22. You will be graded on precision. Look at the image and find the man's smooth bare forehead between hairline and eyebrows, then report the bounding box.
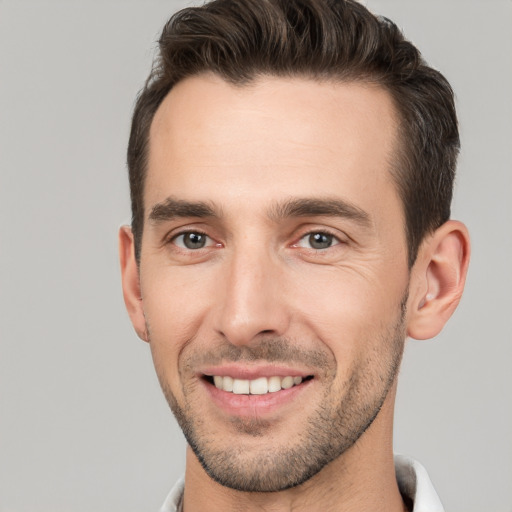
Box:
[145,75,397,224]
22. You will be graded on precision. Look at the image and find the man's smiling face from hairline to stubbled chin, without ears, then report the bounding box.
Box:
[135,75,409,491]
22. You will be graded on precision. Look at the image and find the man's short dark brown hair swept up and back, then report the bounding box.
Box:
[128,0,459,266]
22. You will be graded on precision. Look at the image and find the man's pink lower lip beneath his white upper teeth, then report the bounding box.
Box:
[203,379,313,418]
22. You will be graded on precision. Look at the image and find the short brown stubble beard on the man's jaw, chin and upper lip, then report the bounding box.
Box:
[148,293,407,492]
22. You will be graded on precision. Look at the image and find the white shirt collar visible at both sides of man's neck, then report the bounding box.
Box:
[160,455,444,512]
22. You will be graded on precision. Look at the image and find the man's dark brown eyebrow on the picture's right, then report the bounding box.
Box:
[269,198,371,227]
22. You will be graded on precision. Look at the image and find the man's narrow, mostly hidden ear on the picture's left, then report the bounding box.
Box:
[119,226,149,341]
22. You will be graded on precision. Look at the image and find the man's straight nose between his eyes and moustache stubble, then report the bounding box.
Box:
[216,248,290,346]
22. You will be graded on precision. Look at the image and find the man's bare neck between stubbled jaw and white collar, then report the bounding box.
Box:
[184,393,406,512]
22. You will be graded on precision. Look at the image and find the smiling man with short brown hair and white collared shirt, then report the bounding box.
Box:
[120,0,469,512]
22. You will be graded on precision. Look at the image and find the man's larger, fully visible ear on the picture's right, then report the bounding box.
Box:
[407,220,470,340]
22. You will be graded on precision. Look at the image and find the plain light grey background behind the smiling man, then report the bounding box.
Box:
[0,0,512,512]
